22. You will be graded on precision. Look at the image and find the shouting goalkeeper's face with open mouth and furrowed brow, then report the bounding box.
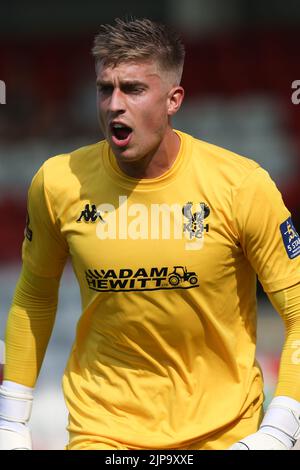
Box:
[96,61,180,162]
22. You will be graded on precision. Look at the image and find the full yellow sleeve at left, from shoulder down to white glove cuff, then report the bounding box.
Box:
[4,166,68,387]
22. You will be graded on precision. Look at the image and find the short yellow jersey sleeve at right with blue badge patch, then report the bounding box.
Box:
[233,167,300,292]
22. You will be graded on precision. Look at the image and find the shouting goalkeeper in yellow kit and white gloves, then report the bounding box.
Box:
[0,19,300,450]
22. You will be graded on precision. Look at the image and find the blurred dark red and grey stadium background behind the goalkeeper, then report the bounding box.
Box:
[0,0,300,449]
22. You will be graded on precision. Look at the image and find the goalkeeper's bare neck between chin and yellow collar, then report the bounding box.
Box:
[117,128,180,179]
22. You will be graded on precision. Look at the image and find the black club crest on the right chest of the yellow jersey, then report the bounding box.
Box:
[182,202,210,240]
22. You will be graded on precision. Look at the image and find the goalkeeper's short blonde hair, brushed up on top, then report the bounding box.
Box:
[92,18,185,84]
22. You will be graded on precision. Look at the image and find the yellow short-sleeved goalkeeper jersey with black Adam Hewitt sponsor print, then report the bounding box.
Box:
[23,131,300,448]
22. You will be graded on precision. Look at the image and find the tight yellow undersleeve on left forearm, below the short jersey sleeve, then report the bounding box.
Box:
[4,266,60,387]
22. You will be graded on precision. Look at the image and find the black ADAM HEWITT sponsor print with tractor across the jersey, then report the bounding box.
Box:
[85,265,199,292]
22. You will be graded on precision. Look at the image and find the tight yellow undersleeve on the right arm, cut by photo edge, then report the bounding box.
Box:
[268,283,300,401]
